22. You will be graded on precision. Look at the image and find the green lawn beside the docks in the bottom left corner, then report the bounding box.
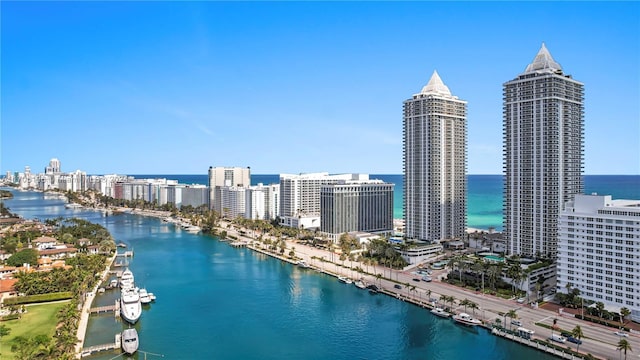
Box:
[0,301,68,360]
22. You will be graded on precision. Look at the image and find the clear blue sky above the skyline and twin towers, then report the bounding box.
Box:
[0,1,640,174]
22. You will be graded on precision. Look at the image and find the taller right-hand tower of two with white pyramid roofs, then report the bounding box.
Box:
[503,44,584,258]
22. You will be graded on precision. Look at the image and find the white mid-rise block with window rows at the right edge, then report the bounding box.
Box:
[556,195,640,322]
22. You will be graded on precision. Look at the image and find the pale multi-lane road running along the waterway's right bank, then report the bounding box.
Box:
[221,222,640,359]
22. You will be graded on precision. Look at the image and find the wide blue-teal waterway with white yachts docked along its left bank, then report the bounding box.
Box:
[5,192,553,360]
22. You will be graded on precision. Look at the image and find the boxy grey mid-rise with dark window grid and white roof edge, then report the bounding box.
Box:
[320,180,394,241]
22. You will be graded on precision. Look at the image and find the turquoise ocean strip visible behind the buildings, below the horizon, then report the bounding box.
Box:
[133,174,640,231]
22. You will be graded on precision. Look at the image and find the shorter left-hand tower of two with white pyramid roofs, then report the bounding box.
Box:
[403,71,467,242]
